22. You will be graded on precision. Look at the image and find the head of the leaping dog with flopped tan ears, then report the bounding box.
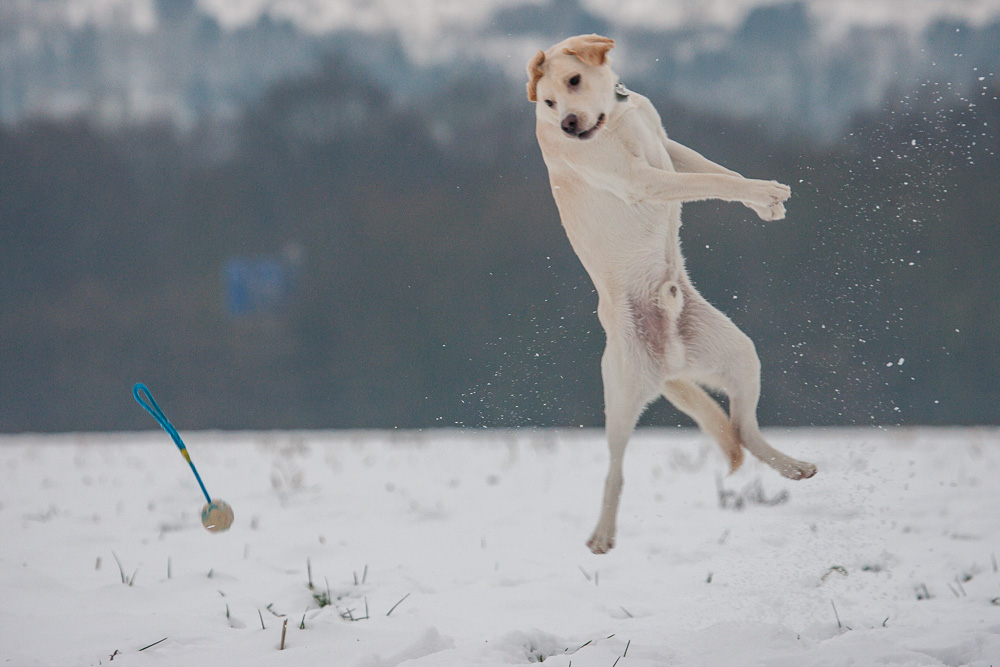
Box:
[528,35,618,140]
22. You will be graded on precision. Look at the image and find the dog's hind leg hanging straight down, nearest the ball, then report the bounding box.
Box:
[587,336,655,554]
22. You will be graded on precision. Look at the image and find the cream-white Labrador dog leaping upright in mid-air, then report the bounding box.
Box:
[528,35,816,553]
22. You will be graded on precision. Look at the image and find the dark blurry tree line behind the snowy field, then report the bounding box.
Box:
[0,58,1000,432]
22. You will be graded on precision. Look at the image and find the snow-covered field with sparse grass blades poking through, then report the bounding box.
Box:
[0,429,1000,667]
